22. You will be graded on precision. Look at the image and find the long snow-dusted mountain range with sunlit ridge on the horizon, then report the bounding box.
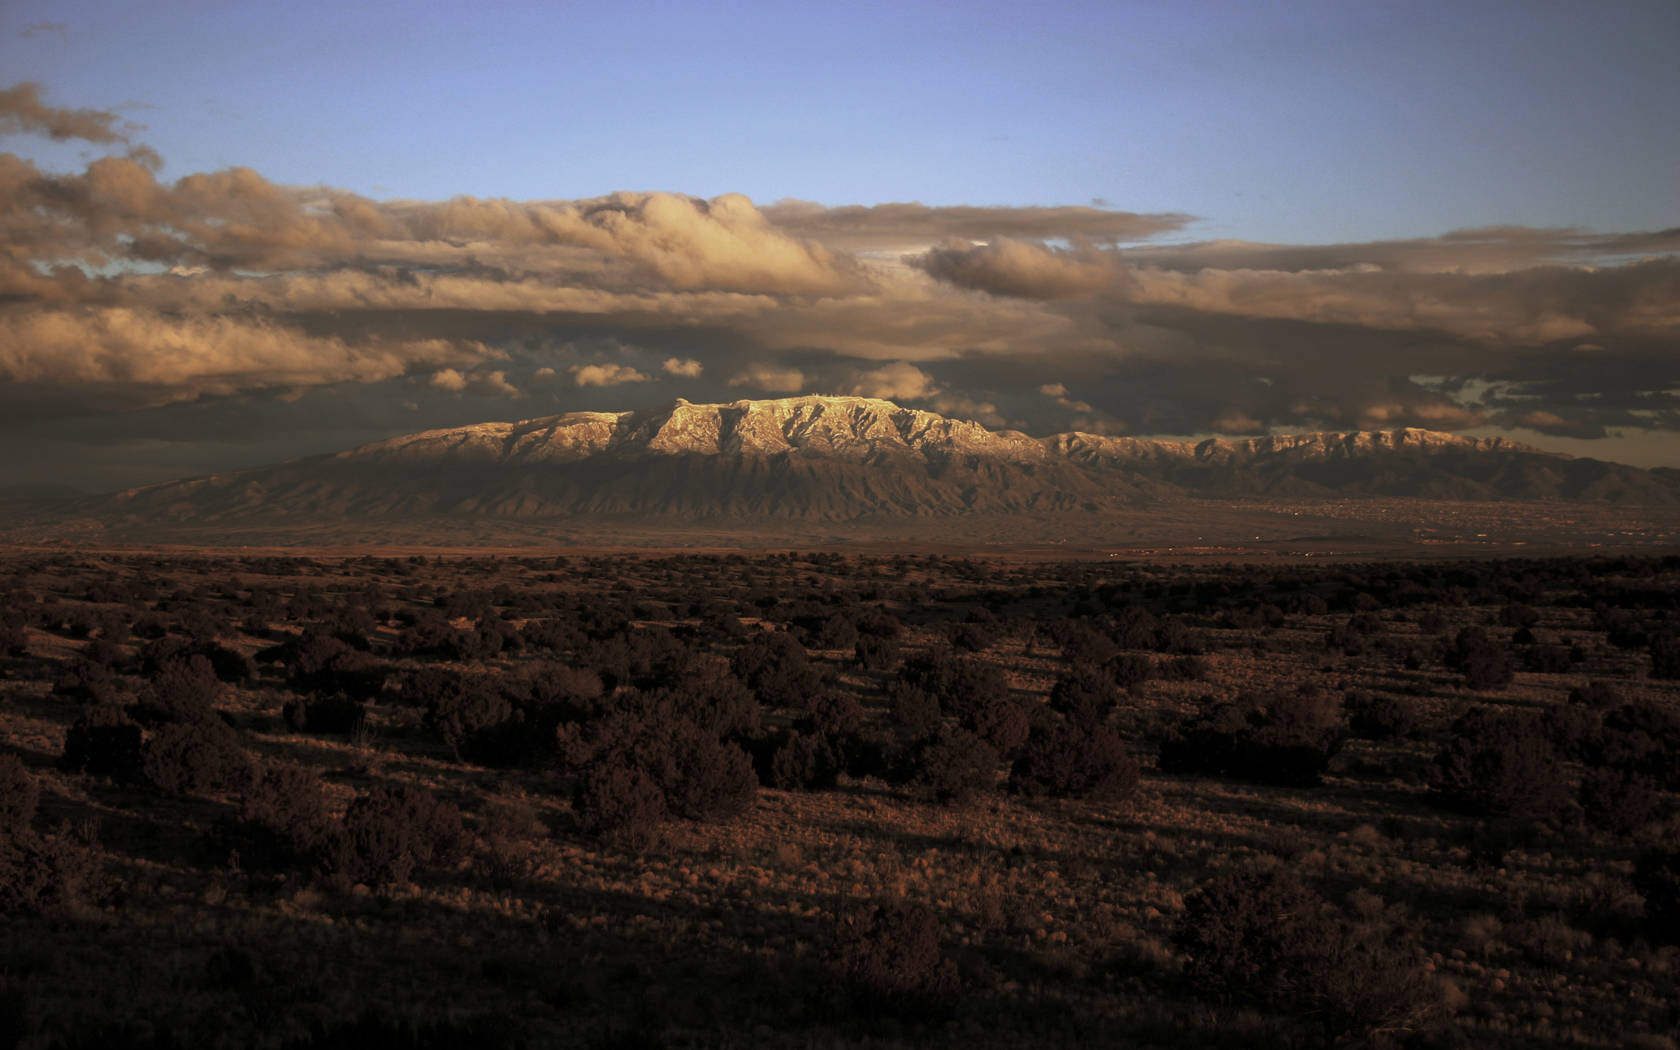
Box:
[10,396,1680,547]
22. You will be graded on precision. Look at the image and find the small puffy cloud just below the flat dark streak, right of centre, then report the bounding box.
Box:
[906,237,1117,299]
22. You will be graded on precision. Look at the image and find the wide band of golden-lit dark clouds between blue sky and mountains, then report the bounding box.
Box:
[0,84,1680,483]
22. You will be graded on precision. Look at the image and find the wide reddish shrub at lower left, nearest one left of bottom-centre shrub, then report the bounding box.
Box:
[324,786,470,885]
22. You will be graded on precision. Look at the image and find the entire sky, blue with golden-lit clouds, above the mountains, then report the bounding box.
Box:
[0,0,1680,492]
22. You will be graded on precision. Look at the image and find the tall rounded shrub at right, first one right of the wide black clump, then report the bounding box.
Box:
[1430,707,1566,820]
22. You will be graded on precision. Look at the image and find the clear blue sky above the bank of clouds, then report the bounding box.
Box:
[0,0,1680,244]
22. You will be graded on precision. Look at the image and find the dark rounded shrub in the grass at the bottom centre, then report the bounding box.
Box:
[828,902,961,1018]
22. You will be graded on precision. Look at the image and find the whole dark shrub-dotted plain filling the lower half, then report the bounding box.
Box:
[0,549,1680,1048]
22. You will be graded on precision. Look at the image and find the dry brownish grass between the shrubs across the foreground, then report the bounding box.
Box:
[0,544,1680,1048]
